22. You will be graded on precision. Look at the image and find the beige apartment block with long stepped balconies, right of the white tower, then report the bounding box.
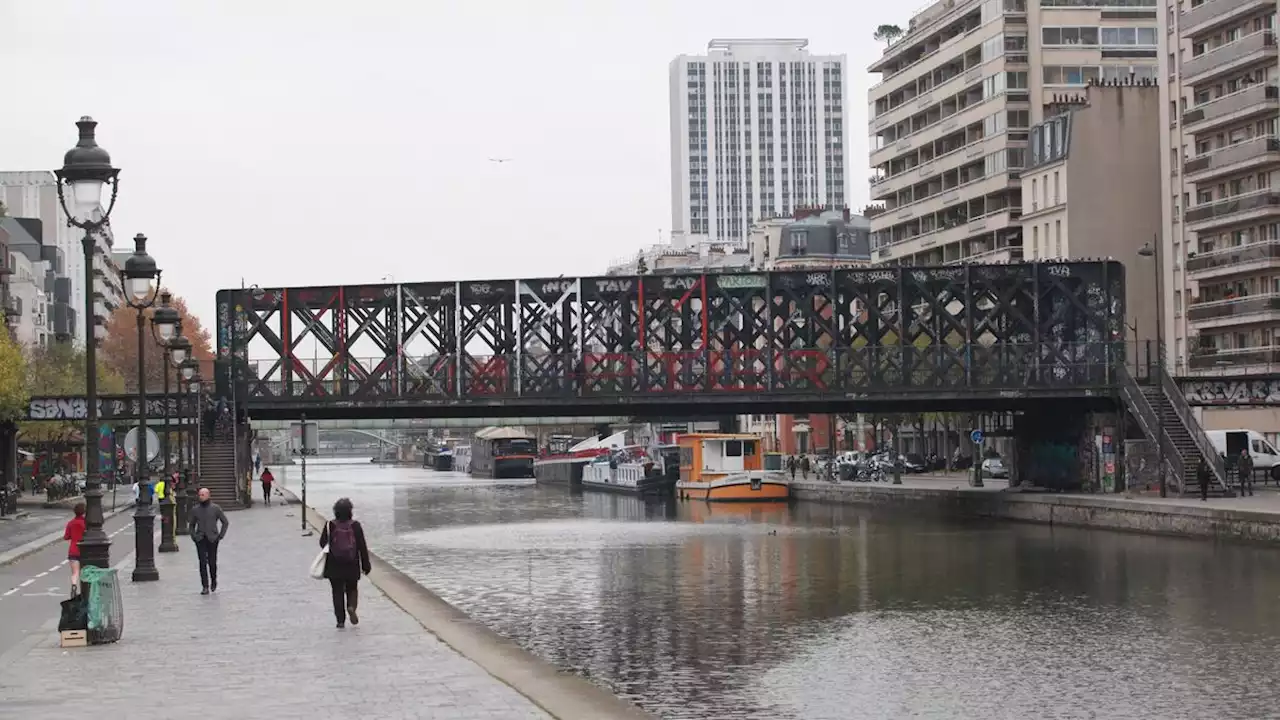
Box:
[869,0,1160,265]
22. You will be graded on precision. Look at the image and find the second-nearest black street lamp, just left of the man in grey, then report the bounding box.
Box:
[124,233,162,582]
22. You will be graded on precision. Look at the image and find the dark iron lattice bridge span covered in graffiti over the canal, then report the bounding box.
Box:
[216,261,1125,420]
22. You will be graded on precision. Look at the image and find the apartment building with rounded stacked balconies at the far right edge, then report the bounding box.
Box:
[1164,0,1280,433]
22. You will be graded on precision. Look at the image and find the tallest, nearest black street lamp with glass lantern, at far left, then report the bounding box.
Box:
[54,115,120,569]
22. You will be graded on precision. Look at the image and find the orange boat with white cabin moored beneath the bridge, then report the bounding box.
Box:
[676,433,791,502]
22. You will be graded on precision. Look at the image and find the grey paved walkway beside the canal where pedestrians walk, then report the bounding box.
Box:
[0,505,549,720]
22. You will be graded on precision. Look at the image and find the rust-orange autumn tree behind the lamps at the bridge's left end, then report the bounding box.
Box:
[100,289,214,392]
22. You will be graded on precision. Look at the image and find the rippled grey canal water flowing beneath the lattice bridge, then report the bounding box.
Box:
[287,464,1280,720]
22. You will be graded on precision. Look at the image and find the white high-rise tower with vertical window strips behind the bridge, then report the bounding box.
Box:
[669,38,846,247]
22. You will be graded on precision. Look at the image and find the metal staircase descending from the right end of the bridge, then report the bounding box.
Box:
[1117,366,1235,497]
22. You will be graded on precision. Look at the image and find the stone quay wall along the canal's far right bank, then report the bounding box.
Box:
[792,474,1280,546]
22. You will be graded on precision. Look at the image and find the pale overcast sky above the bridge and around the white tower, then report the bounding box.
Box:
[0,0,896,325]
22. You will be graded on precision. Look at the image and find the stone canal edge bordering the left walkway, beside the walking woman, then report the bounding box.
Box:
[279,487,653,720]
